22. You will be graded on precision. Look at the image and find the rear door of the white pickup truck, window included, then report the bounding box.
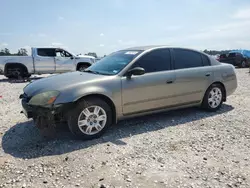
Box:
[33,48,55,73]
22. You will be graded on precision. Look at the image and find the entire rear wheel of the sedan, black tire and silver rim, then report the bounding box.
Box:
[202,84,225,112]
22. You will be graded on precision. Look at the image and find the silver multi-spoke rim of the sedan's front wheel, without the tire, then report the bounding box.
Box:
[78,106,107,135]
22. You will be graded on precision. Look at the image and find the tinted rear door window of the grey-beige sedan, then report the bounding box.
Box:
[174,49,203,69]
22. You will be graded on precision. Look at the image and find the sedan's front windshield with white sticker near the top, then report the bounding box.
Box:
[86,50,142,75]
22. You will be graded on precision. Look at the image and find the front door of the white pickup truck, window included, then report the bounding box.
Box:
[55,49,75,72]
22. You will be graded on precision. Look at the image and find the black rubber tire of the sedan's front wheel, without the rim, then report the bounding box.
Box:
[67,97,112,140]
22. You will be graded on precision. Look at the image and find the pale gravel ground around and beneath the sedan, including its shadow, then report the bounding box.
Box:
[0,69,250,188]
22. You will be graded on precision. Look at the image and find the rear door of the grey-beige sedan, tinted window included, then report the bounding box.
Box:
[173,48,213,105]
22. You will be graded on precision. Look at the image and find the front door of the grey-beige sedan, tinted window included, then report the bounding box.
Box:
[122,49,175,115]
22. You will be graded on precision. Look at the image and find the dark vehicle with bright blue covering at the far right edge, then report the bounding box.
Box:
[219,50,250,68]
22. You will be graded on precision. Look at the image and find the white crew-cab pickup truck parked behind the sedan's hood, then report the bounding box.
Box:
[0,47,95,78]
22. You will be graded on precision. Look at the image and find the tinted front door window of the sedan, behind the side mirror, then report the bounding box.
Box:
[132,49,171,73]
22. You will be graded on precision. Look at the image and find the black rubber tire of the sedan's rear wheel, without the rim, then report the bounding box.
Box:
[201,84,225,112]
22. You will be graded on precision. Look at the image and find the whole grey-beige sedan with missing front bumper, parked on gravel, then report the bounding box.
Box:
[20,46,237,139]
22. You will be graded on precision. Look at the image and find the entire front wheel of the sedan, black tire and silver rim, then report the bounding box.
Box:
[68,98,112,140]
